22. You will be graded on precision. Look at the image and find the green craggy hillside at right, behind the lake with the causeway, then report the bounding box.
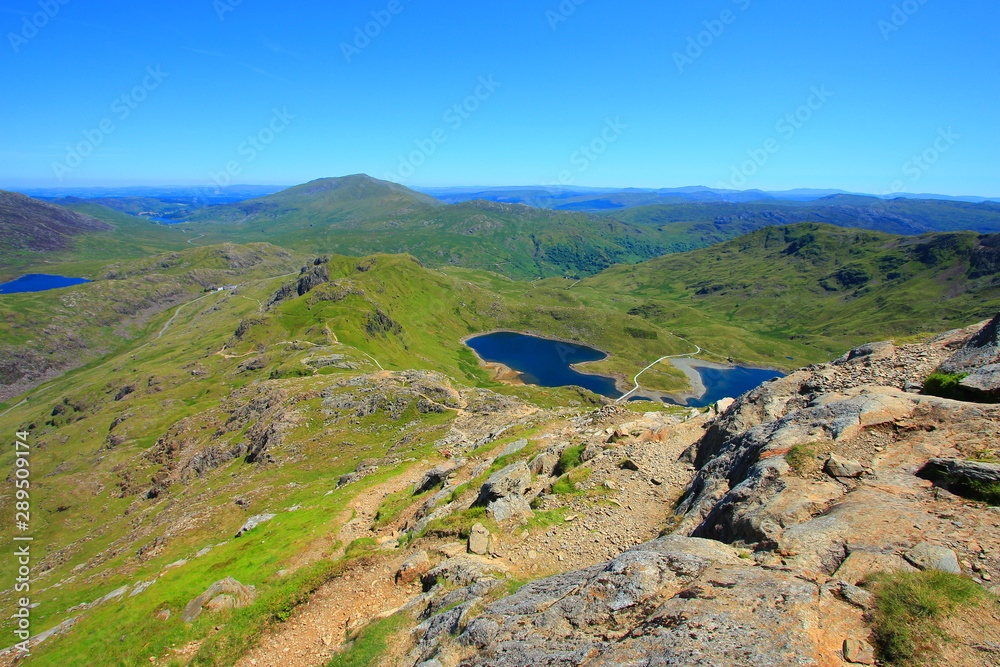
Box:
[574,223,1000,346]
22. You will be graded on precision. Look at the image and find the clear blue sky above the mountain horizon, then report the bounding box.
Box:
[0,0,1000,196]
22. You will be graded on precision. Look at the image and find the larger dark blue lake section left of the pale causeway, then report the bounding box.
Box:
[465,331,621,398]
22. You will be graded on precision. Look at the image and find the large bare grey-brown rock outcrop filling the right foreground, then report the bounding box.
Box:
[401,318,1000,667]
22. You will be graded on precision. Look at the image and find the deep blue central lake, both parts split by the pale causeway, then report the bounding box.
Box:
[466,331,783,408]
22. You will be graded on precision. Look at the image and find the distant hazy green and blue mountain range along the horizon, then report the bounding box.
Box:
[0,174,1000,279]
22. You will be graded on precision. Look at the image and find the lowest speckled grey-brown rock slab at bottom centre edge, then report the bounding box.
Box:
[419,536,850,667]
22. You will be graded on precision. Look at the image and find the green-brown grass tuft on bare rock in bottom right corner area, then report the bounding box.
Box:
[870,570,986,665]
